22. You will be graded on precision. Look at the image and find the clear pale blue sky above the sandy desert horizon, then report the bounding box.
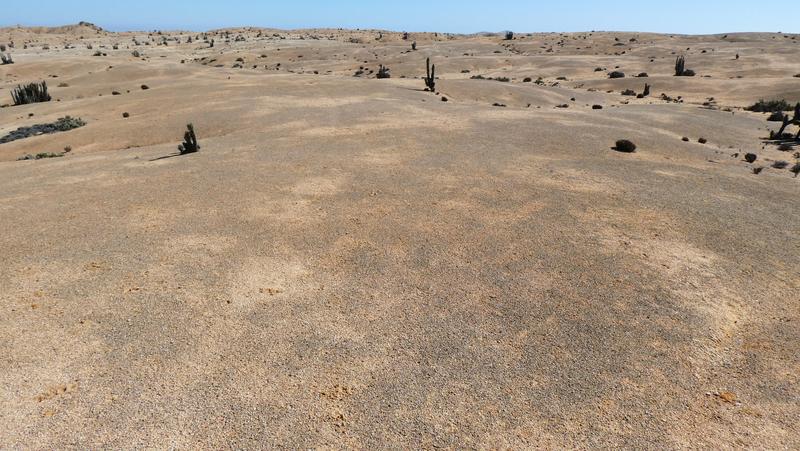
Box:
[0,0,800,34]
